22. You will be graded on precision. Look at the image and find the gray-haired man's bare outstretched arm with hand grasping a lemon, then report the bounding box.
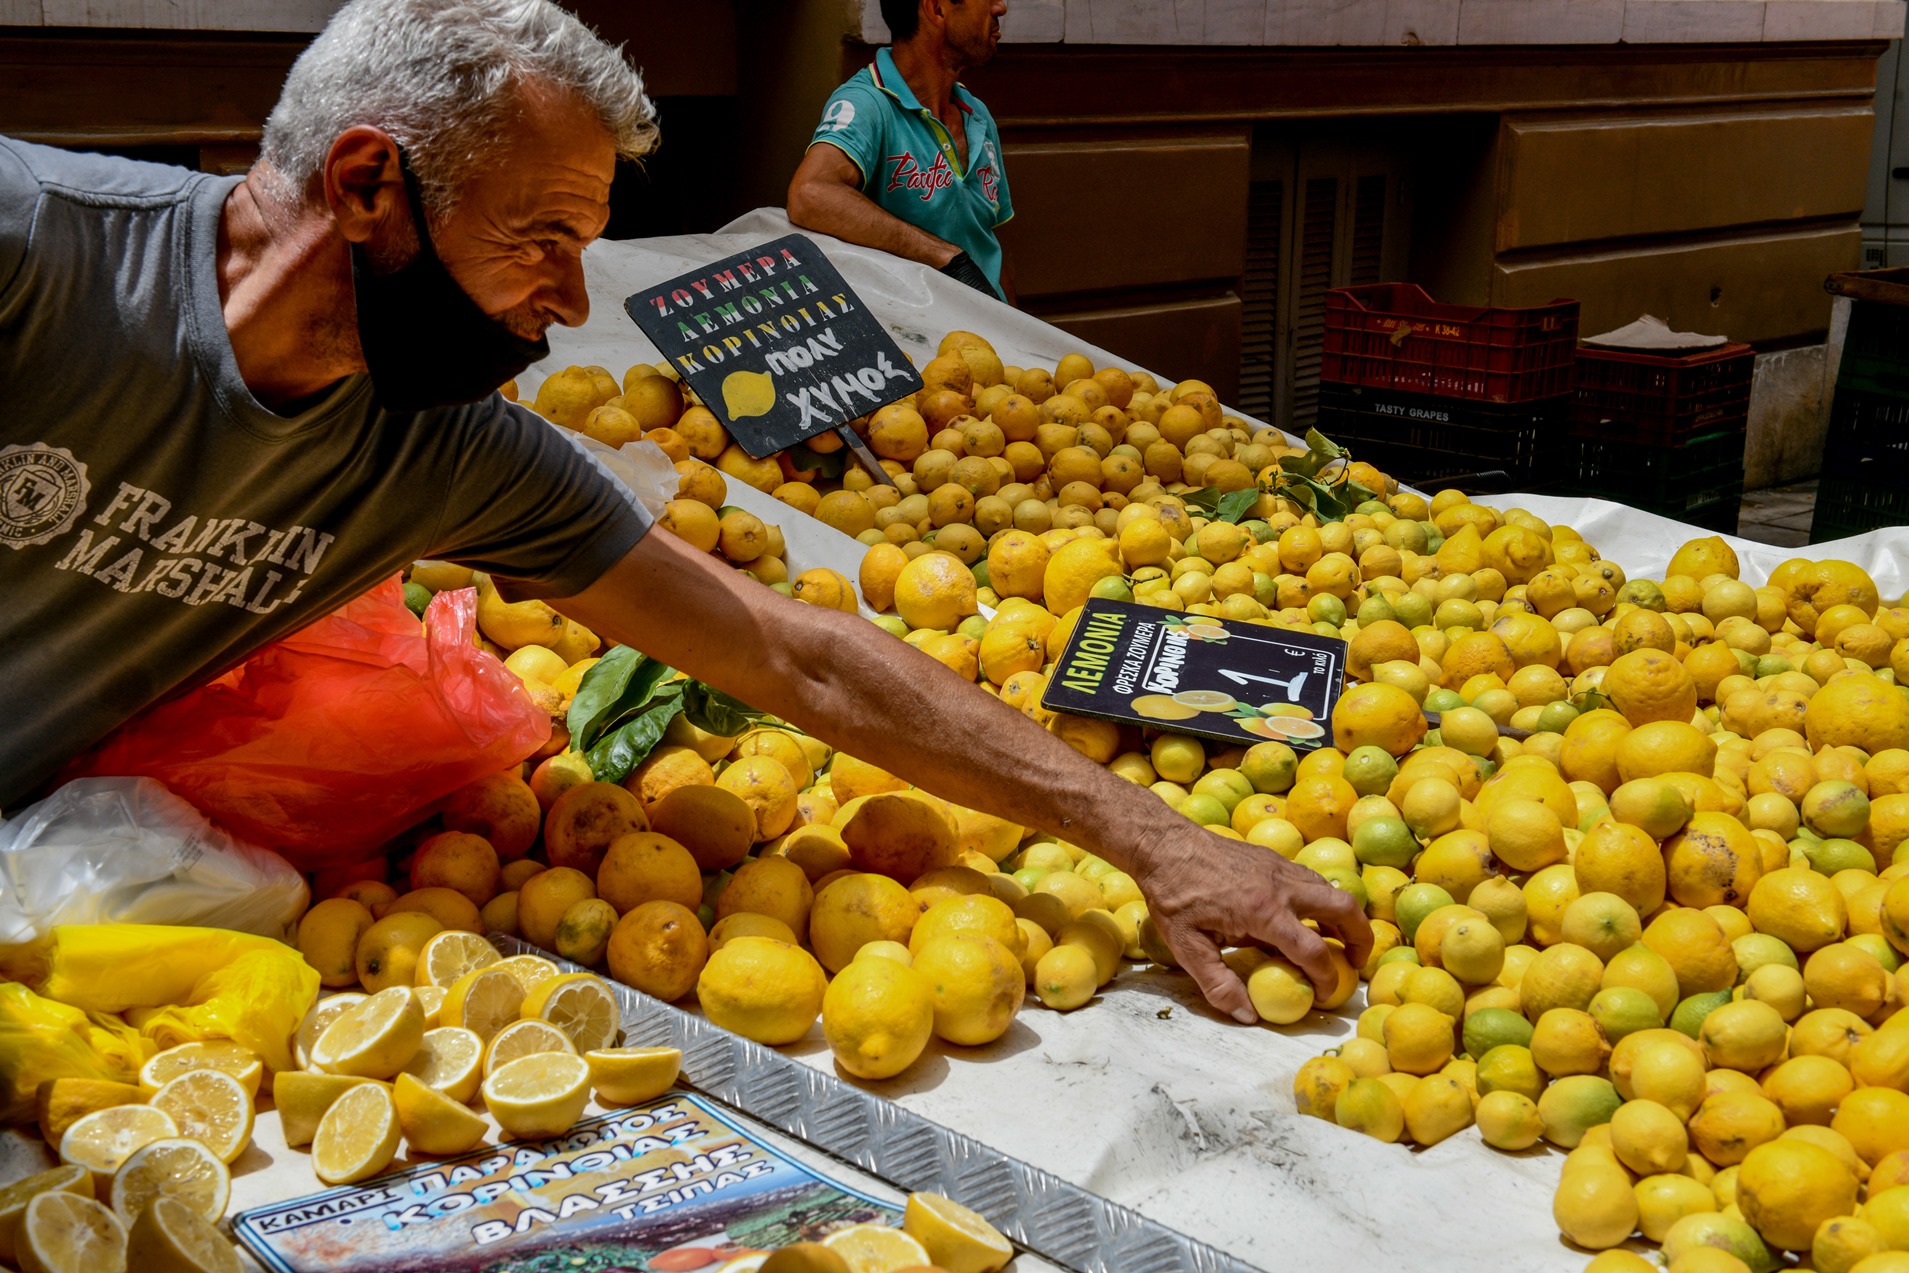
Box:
[556,531,1373,1021]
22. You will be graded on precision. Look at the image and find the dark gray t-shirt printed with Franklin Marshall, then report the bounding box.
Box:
[0,137,649,807]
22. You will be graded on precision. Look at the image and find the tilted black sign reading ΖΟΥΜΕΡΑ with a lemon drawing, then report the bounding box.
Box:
[622,235,922,460]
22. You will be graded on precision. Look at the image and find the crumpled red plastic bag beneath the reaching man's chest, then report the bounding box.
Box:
[61,576,550,870]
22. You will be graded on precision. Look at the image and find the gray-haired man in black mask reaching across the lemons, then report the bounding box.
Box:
[0,0,1371,1021]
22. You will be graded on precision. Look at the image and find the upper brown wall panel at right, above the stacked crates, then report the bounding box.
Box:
[1497,105,1875,252]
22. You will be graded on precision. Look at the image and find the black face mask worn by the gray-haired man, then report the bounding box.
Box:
[351,151,550,410]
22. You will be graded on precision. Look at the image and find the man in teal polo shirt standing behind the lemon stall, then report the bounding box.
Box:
[788,0,1014,302]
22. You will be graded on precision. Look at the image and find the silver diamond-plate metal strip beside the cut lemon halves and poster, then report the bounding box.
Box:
[491,933,1260,1273]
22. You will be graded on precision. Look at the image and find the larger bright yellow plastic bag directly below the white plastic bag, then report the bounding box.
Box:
[15,924,319,1071]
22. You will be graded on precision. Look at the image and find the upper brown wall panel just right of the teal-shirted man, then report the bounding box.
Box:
[1000,130,1252,296]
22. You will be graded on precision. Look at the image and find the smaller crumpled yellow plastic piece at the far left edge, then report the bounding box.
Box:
[0,981,155,1122]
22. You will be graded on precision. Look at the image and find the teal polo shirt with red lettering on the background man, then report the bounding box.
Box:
[809,48,1014,294]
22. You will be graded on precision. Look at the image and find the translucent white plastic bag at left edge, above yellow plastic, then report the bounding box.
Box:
[0,779,309,945]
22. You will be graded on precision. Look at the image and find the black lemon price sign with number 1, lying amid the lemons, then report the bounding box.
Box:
[1040,599,1346,752]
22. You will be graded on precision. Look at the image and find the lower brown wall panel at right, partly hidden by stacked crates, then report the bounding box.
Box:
[1491,225,1861,342]
